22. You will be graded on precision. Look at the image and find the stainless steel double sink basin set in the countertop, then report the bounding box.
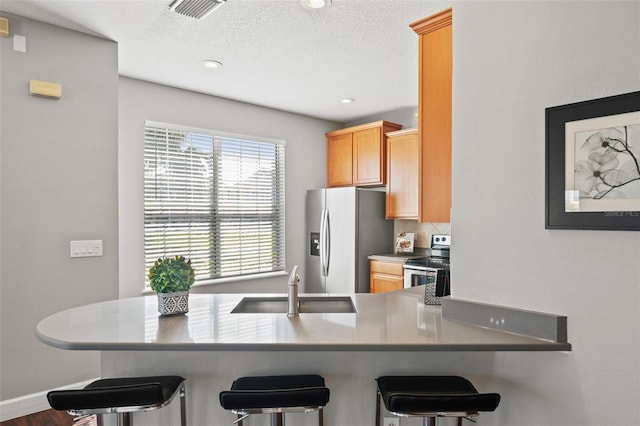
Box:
[231,296,358,314]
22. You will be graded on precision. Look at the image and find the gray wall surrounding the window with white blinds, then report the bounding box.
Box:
[118,77,342,297]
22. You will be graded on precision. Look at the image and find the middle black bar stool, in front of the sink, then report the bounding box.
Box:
[220,374,329,426]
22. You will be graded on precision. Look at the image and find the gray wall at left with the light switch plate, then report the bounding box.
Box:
[0,14,118,400]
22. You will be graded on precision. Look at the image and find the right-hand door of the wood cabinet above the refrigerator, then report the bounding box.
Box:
[353,127,385,185]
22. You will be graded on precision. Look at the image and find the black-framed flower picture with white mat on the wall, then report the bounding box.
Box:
[545,92,640,231]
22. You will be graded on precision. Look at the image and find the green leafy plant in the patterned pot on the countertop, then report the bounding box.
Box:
[149,256,196,293]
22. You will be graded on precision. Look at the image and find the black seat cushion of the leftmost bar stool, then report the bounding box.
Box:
[47,376,185,410]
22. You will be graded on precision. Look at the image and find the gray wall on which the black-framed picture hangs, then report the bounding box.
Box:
[451,1,640,426]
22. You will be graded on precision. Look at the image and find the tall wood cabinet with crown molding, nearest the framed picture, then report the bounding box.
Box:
[411,9,453,222]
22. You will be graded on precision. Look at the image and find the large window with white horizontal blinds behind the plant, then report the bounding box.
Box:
[144,121,284,283]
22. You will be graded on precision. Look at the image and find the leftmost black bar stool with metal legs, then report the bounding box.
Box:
[47,376,187,426]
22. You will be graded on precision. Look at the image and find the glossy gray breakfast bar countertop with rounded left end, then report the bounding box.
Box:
[36,287,571,351]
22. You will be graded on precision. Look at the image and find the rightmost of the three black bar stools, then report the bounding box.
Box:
[376,376,500,426]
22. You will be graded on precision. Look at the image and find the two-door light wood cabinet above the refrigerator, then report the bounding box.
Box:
[326,121,402,187]
